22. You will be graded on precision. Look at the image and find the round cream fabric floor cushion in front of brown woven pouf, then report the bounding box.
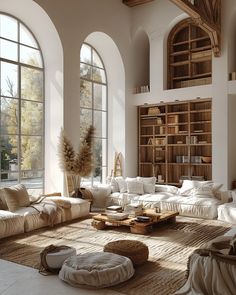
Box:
[59,252,134,288]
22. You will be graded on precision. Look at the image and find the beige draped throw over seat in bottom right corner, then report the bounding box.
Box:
[175,236,236,295]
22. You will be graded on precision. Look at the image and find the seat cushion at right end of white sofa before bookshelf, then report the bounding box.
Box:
[160,196,221,219]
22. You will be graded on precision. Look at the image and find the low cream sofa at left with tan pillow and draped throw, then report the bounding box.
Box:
[0,185,90,239]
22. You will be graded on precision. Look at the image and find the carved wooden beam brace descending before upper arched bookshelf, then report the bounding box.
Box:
[170,0,221,56]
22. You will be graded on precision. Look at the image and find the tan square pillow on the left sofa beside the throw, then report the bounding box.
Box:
[4,184,30,212]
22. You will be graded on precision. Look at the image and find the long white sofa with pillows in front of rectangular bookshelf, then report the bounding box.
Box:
[92,177,231,219]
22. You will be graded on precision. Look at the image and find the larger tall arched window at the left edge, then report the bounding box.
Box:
[0,13,44,192]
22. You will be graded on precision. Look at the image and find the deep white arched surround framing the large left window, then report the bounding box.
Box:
[1,0,63,192]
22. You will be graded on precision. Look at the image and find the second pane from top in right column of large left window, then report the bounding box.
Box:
[20,45,43,67]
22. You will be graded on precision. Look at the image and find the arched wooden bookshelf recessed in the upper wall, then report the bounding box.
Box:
[167,18,212,89]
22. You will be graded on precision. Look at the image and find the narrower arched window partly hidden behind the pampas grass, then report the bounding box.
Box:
[80,43,107,184]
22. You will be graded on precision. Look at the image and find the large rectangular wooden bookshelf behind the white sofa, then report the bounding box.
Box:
[138,99,212,184]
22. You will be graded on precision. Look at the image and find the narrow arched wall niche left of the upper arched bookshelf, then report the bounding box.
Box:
[132,28,150,93]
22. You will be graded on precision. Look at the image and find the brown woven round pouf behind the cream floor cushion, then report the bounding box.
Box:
[103,240,149,265]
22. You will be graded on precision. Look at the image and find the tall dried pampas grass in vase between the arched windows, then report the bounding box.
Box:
[58,125,95,197]
